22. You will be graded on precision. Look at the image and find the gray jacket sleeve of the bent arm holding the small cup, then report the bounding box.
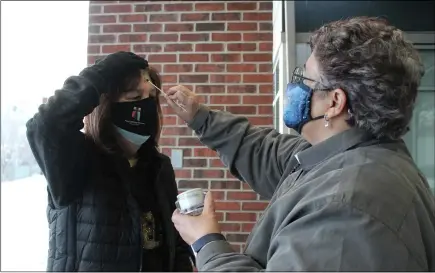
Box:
[197,202,418,272]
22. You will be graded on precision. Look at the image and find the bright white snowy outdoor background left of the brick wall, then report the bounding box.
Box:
[1,1,89,271]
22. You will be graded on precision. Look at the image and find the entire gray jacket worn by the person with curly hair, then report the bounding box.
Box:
[189,106,435,271]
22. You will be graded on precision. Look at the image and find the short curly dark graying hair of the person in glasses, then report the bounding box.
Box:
[310,17,424,139]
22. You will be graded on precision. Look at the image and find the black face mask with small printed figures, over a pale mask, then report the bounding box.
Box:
[111,97,158,146]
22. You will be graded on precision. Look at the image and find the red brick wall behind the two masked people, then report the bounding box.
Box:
[88,1,273,250]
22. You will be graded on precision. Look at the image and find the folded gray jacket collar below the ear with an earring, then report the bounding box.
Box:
[295,128,374,171]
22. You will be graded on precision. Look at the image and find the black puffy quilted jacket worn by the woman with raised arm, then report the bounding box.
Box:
[27,74,192,271]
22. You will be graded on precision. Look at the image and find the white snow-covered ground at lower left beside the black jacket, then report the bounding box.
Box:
[1,175,48,271]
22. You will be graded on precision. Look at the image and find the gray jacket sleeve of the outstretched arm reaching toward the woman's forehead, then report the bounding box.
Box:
[189,106,307,198]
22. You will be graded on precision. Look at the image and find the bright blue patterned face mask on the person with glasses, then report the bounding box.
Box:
[284,82,323,134]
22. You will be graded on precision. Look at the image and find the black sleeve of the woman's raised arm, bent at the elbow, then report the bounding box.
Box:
[26,76,99,207]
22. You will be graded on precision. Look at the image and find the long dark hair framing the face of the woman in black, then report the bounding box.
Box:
[84,67,163,153]
